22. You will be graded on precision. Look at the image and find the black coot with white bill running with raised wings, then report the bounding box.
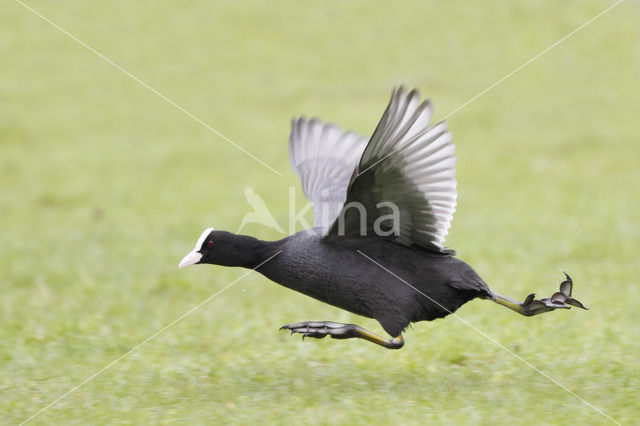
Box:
[179,87,586,349]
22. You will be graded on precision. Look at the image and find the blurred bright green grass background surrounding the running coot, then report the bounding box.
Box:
[0,0,640,424]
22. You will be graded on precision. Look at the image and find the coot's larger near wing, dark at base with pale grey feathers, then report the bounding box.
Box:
[327,87,457,251]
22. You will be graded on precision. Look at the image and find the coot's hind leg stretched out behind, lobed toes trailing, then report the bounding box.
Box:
[492,273,589,317]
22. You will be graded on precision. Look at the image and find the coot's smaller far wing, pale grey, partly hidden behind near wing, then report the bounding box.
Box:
[289,117,367,228]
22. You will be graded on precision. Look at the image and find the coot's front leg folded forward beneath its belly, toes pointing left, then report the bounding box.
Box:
[280,321,404,349]
